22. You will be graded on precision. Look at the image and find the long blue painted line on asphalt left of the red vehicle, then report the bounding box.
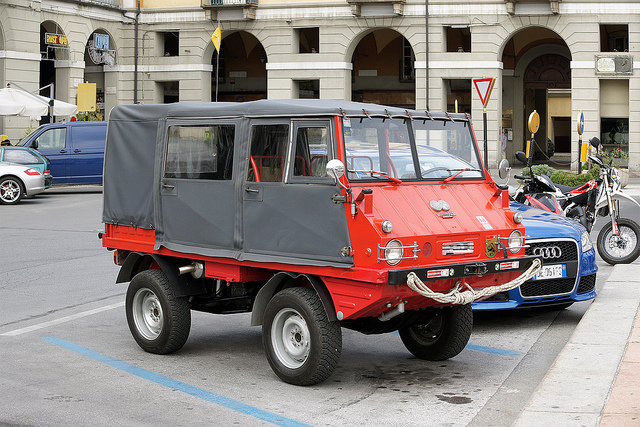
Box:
[41,337,308,427]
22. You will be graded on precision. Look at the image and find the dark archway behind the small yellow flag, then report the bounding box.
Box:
[211,31,267,102]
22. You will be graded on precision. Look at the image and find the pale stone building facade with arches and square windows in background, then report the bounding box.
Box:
[0,0,640,171]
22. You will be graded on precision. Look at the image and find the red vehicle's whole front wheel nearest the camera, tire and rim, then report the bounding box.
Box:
[262,288,342,385]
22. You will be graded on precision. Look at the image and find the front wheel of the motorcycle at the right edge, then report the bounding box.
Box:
[597,218,640,265]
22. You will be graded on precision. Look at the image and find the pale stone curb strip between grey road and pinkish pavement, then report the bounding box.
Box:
[514,264,640,427]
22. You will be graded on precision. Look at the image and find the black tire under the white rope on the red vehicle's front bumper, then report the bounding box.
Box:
[398,304,473,360]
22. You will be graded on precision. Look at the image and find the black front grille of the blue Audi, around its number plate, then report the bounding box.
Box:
[520,240,578,298]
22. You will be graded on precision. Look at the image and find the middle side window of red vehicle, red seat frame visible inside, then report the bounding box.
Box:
[247,124,289,182]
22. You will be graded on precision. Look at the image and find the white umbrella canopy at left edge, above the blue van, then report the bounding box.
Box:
[0,87,78,118]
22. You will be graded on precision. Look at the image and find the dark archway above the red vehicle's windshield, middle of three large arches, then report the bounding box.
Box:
[351,29,416,108]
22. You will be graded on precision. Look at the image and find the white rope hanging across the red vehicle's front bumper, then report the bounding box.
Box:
[407,258,542,305]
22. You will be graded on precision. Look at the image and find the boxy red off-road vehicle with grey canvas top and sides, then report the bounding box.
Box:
[102,100,539,385]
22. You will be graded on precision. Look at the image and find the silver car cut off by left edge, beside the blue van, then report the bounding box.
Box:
[0,162,44,205]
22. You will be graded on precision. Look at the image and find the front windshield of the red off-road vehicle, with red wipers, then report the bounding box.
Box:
[343,117,483,182]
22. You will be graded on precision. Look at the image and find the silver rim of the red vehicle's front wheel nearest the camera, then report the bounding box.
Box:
[271,308,311,369]
